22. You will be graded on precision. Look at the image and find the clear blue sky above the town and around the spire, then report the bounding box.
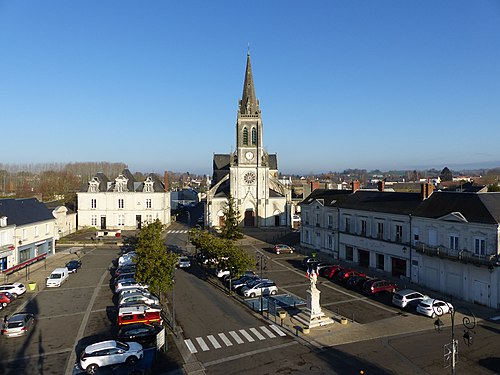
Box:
[0,0,500,174]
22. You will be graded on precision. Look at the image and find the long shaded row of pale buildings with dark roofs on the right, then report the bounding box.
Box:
[300,181,500,308]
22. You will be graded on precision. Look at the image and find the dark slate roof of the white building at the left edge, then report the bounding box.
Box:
[0,198,54,225]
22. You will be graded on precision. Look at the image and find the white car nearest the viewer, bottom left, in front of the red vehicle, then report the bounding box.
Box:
[80,340,144,374]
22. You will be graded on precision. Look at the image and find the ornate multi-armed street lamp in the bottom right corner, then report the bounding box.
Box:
[431,300,476,375]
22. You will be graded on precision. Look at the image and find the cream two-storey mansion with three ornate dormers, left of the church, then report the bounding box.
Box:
[77,169,171,230]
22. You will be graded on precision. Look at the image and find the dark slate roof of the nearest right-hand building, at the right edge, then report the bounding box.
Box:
[413,191,500,224]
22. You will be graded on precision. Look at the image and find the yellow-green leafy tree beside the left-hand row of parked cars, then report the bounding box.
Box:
[135,219,178,295]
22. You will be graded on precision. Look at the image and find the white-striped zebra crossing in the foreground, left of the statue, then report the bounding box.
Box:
[184,324,286,354]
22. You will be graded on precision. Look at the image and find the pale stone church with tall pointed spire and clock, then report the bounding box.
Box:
[206,53,292,228]
